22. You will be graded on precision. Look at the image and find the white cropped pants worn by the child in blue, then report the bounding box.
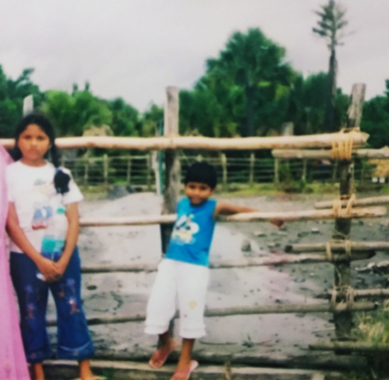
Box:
[145,259,209,339]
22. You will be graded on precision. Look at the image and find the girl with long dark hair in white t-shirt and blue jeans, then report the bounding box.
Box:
[7,114,95,380]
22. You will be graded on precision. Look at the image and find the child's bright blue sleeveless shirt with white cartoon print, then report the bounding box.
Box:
[165,198,216,266]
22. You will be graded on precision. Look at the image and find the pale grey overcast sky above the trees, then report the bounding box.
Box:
[0,0,389,111]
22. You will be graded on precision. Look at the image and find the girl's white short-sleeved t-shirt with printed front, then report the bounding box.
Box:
[6,161,83,253]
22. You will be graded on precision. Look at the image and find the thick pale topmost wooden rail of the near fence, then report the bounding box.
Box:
[0,132,369,150]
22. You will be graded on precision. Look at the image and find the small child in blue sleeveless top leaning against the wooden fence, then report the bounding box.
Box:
[145,162,282,380]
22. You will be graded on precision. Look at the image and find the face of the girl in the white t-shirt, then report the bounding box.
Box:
[17,124,50,166]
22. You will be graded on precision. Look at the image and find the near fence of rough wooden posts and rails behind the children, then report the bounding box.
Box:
[0,86,388,378]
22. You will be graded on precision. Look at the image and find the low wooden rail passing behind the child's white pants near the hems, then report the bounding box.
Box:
[47,302,377,326]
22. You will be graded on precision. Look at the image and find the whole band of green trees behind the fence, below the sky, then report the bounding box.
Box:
[0,29,389,148]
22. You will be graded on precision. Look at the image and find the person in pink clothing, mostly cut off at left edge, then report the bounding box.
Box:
[0,145,30,380]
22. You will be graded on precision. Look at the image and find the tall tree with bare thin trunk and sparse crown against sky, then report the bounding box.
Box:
[312,0,348,132]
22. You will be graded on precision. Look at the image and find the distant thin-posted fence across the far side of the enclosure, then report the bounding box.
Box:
[62,152,375,191]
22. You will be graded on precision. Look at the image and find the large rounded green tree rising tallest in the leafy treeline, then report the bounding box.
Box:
[180,29,293,136]
